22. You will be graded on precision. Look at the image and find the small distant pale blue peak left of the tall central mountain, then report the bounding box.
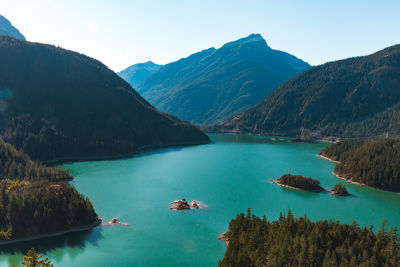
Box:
[118,61,162,88]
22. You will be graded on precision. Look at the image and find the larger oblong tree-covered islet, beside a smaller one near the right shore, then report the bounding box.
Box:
[272,174,326,192]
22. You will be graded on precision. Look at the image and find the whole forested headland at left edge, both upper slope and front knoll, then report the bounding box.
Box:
[0,139,98,241]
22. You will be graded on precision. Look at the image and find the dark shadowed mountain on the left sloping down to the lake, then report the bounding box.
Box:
[0,36,209,160]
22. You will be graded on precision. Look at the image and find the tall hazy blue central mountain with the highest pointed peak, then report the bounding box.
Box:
[137,34,310,125]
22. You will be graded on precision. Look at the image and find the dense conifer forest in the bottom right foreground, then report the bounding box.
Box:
[218,211,400,267]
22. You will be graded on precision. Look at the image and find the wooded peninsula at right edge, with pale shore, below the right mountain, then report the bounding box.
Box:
[321,139,400,192]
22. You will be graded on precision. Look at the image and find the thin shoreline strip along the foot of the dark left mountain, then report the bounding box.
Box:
[40,141,211,165]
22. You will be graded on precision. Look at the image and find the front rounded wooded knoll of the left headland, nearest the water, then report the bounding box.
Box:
[0,180,96,239]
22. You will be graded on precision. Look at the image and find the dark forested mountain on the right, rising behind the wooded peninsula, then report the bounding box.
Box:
[208,45,400,137]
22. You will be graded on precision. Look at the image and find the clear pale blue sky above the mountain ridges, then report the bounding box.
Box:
[0,0,400,71]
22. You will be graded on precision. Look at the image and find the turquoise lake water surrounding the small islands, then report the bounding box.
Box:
[0,135,400,266]
